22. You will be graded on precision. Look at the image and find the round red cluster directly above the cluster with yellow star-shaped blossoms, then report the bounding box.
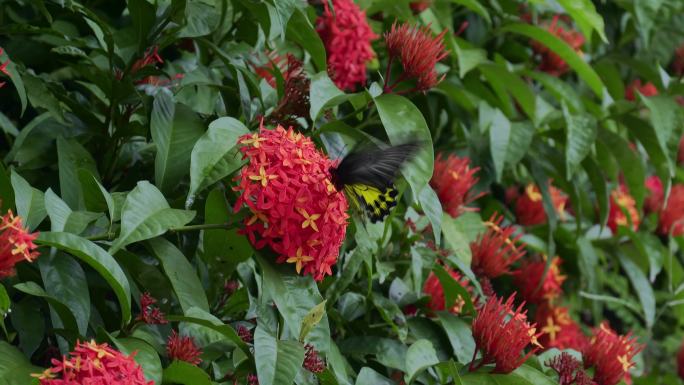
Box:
[513,256,566,305]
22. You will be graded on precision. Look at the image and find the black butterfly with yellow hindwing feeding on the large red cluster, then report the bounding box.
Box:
[330,141,420,223]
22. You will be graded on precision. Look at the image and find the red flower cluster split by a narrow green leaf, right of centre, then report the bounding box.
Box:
[515,183,568,226]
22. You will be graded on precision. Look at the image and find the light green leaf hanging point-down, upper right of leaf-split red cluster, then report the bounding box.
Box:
[563,103,597,180]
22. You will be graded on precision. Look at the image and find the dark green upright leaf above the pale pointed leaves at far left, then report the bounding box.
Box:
[57,137,98,209]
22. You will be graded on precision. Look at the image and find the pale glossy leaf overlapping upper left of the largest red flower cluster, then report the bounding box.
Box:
[185,117,249,208]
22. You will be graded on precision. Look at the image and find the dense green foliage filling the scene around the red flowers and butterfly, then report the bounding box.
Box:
[0,0,684,385]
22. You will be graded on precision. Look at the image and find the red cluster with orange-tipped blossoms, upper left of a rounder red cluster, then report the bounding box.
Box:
[470,213,525,278]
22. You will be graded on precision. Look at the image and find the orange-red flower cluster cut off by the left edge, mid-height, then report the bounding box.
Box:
[0,210,39,279]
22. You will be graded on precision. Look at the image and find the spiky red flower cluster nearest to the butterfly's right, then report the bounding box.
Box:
[430,153,484,218]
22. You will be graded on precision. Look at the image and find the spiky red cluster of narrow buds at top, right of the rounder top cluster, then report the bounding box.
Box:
[385,22,448,94]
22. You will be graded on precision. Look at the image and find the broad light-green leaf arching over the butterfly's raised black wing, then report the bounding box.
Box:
[375,94,435,197]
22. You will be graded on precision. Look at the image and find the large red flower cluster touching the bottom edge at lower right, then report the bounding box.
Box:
[582,322,644,385]
